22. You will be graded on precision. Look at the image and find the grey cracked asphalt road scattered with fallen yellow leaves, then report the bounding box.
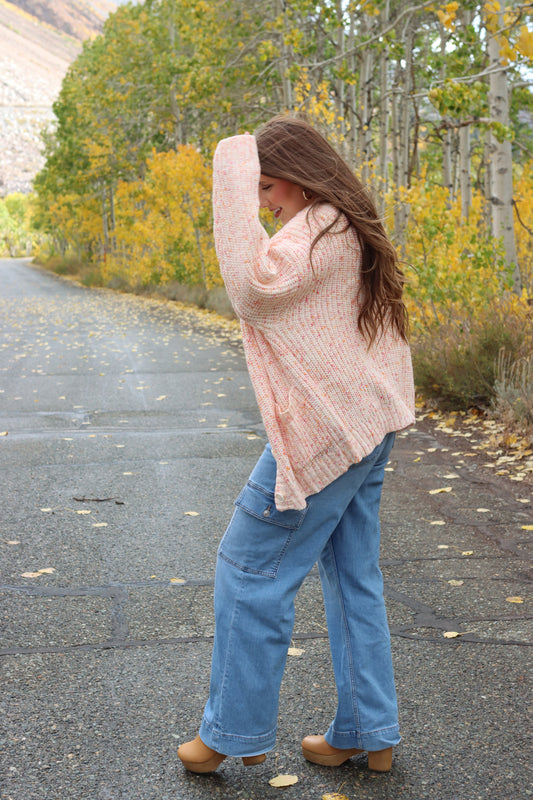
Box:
[0,260,533,800]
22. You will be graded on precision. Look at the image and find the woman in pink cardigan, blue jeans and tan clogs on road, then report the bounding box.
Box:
[178,116,414,772]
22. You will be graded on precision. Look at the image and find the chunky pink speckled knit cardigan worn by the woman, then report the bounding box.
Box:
[213,134,414,511]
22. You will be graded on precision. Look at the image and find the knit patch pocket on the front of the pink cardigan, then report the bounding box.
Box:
[276,387,332,469]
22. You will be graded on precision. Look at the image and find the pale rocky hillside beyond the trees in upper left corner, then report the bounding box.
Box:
[0,0,116,196]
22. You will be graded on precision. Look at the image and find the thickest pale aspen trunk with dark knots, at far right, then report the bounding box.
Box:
[487,11,521,293]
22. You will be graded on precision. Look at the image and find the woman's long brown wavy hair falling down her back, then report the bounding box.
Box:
[255,116,408,345]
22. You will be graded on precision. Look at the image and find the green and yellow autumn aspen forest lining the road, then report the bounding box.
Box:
[0,0,533,435]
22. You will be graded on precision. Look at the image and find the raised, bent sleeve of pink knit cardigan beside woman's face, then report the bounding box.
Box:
[213,134,312,324]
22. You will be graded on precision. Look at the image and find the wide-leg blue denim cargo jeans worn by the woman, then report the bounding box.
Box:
[200,433,400,756]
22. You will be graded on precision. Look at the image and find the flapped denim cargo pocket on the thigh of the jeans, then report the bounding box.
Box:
[218,481,307,578]
